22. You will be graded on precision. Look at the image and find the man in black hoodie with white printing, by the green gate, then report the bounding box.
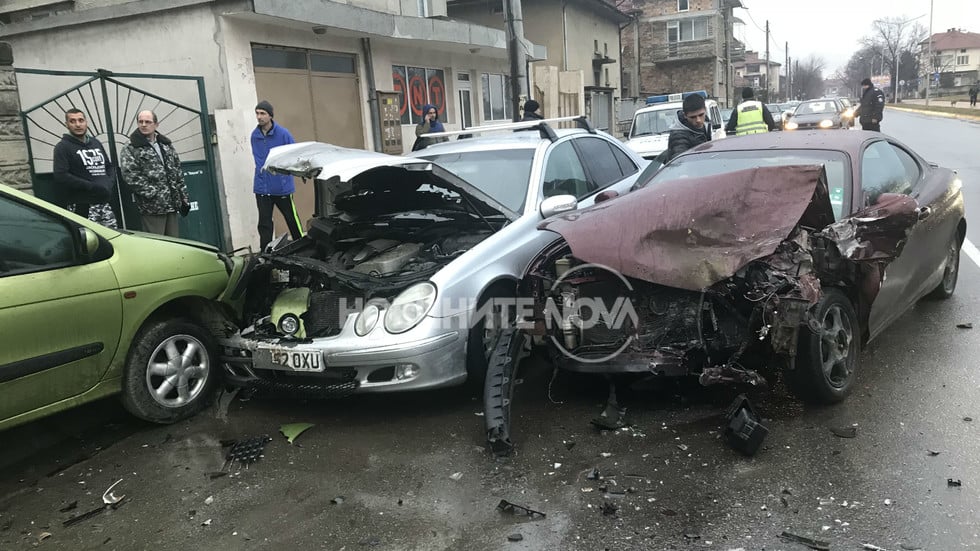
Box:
[54,108,117,228]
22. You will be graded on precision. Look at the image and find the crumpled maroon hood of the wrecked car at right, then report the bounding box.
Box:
[539,165,834,291]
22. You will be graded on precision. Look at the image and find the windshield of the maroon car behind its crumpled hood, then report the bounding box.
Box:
[637,150,851,220]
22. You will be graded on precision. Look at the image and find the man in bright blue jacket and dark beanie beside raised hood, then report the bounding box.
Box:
[252,100,303,250]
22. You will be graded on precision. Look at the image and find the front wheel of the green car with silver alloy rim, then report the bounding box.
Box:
[122,319,220,424]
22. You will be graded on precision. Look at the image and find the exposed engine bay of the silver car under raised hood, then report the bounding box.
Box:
[238,217,497,339]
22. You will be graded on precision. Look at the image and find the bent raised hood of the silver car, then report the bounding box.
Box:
[263,142,518,220]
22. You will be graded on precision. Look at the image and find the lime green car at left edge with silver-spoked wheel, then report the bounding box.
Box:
[0,185,241,429]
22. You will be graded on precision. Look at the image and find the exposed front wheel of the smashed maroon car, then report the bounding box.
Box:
[786,287,861,404]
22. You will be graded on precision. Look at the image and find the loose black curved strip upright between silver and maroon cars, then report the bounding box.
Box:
[483,328,524,457]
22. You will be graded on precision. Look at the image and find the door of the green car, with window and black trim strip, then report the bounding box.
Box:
[0,193,122,419]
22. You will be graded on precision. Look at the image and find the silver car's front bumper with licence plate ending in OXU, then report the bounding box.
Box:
[219,315,467,395]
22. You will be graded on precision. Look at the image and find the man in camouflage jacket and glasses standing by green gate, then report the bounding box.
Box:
[119,111,191,237]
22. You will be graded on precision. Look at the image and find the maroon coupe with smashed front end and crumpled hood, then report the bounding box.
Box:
[485,131,966,458]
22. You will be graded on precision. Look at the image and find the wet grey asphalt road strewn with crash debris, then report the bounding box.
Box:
[0,111,980,551]
